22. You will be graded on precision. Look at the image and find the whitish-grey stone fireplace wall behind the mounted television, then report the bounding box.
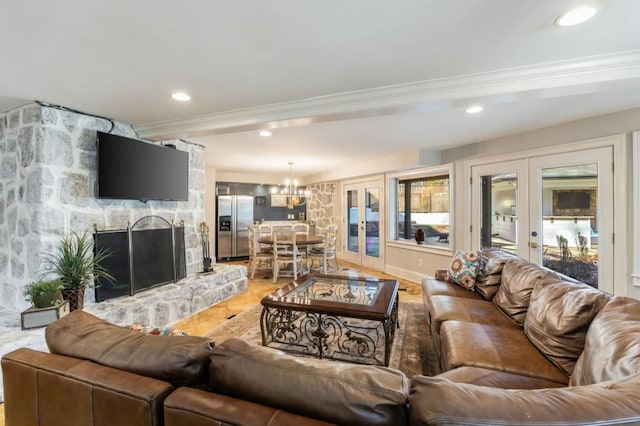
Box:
[0,104,205,311]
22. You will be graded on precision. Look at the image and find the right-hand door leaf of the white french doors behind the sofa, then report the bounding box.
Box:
[530,148,614,292]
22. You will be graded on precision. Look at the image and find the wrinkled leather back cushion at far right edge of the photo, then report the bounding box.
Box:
[570,297,640,386]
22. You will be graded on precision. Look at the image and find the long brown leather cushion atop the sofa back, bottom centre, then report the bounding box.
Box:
[210,339,409,426]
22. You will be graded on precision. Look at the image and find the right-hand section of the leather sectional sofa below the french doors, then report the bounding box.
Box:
[416,251,640,425]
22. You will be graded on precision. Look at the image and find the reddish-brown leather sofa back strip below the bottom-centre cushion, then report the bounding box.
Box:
[164,388,333,426]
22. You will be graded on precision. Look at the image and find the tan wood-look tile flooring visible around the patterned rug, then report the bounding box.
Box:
[0,261,422,426]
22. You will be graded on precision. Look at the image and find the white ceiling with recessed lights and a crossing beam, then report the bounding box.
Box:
[0,0,640,180]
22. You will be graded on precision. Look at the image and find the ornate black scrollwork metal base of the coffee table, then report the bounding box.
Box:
[260,298,398,366]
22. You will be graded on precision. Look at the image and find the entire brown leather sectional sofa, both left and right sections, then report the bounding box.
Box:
[2,248,640,426]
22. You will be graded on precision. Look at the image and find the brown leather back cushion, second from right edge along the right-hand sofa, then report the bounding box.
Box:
[524,281,610,376]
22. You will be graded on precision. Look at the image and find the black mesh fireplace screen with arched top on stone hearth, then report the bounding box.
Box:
[94,216,186,302]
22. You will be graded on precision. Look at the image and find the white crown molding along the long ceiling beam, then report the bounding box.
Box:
[134,50,640,139]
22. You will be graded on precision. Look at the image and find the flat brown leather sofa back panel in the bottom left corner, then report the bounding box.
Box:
[2,348,173,426]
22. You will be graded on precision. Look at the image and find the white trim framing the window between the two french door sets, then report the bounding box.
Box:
[386,163,456,254]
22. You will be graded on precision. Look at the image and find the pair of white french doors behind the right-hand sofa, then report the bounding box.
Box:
[471,147,614,293]
